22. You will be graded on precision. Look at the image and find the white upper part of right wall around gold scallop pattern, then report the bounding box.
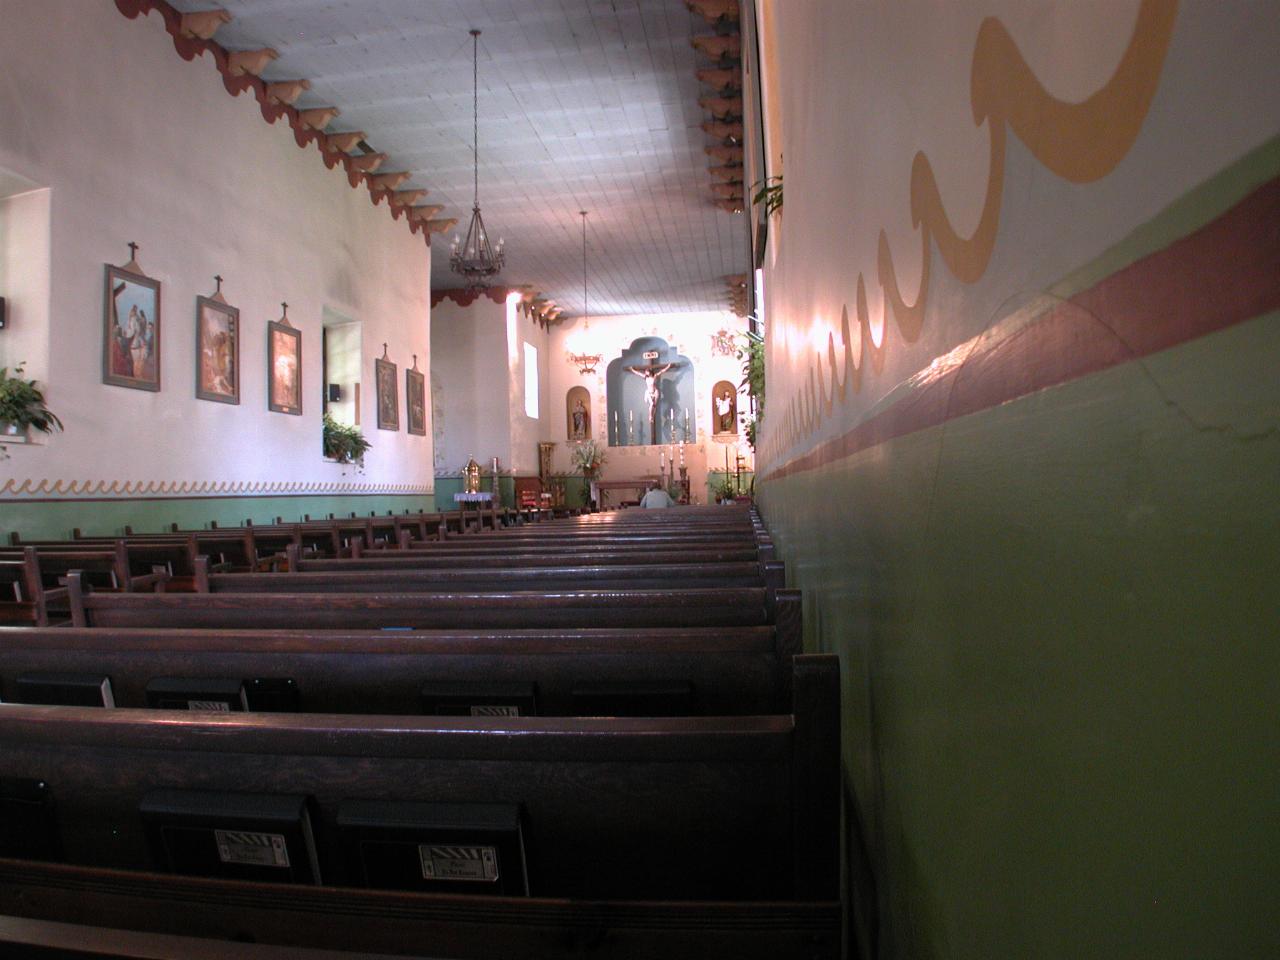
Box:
[762,0,1280,471]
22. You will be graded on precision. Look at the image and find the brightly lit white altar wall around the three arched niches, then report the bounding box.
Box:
[544,311,753,500]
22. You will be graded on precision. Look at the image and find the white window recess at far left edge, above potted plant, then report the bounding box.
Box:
[0,189,50,373]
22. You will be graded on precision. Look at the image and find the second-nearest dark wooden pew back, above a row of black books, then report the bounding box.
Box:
[0,626,799,716]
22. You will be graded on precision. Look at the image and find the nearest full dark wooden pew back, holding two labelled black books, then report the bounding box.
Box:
[0,655,840,959]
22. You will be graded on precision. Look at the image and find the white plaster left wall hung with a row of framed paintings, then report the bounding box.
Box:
[0,0,433,490]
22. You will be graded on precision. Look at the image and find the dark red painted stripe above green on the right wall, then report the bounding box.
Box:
[764,178,1280,481]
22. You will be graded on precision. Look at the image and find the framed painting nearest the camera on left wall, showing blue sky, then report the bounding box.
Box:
[102,264,160,390]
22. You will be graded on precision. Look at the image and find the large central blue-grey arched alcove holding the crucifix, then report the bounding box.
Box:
[604,337,698,447]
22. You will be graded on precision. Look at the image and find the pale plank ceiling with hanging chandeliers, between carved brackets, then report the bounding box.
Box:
[173,0,749,316]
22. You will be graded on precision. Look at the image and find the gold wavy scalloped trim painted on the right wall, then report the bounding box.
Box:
[760,0,1178,465]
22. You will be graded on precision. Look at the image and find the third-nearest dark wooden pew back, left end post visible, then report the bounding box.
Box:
[68,573,792,630]
